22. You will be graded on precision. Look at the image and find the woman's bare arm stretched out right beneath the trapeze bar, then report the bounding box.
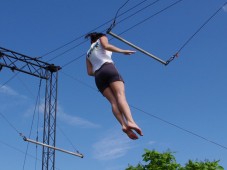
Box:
[100,36,135,55]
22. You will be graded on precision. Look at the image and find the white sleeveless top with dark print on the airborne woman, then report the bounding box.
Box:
[87,39,113,72]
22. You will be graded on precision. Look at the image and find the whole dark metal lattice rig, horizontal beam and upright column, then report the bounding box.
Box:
[0,47,61,170]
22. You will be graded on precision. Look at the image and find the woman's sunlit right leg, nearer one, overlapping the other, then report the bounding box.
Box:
[110,81,143,136]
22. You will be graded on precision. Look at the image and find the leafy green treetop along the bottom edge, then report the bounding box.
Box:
[126,149,224,170]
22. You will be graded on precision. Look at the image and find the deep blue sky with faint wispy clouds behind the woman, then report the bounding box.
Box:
[0,0,227,170]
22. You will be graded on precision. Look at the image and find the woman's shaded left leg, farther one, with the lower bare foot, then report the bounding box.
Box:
[103,87,138,140]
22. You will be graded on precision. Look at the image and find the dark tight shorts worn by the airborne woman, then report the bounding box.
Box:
[95,63,124,93]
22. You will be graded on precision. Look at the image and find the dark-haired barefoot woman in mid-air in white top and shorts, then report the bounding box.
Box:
[85,32,143,140]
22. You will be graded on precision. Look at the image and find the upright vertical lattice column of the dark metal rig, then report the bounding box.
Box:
[42,66,58,170]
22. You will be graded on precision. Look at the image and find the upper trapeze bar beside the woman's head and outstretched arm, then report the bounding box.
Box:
[107,31,167,65]
